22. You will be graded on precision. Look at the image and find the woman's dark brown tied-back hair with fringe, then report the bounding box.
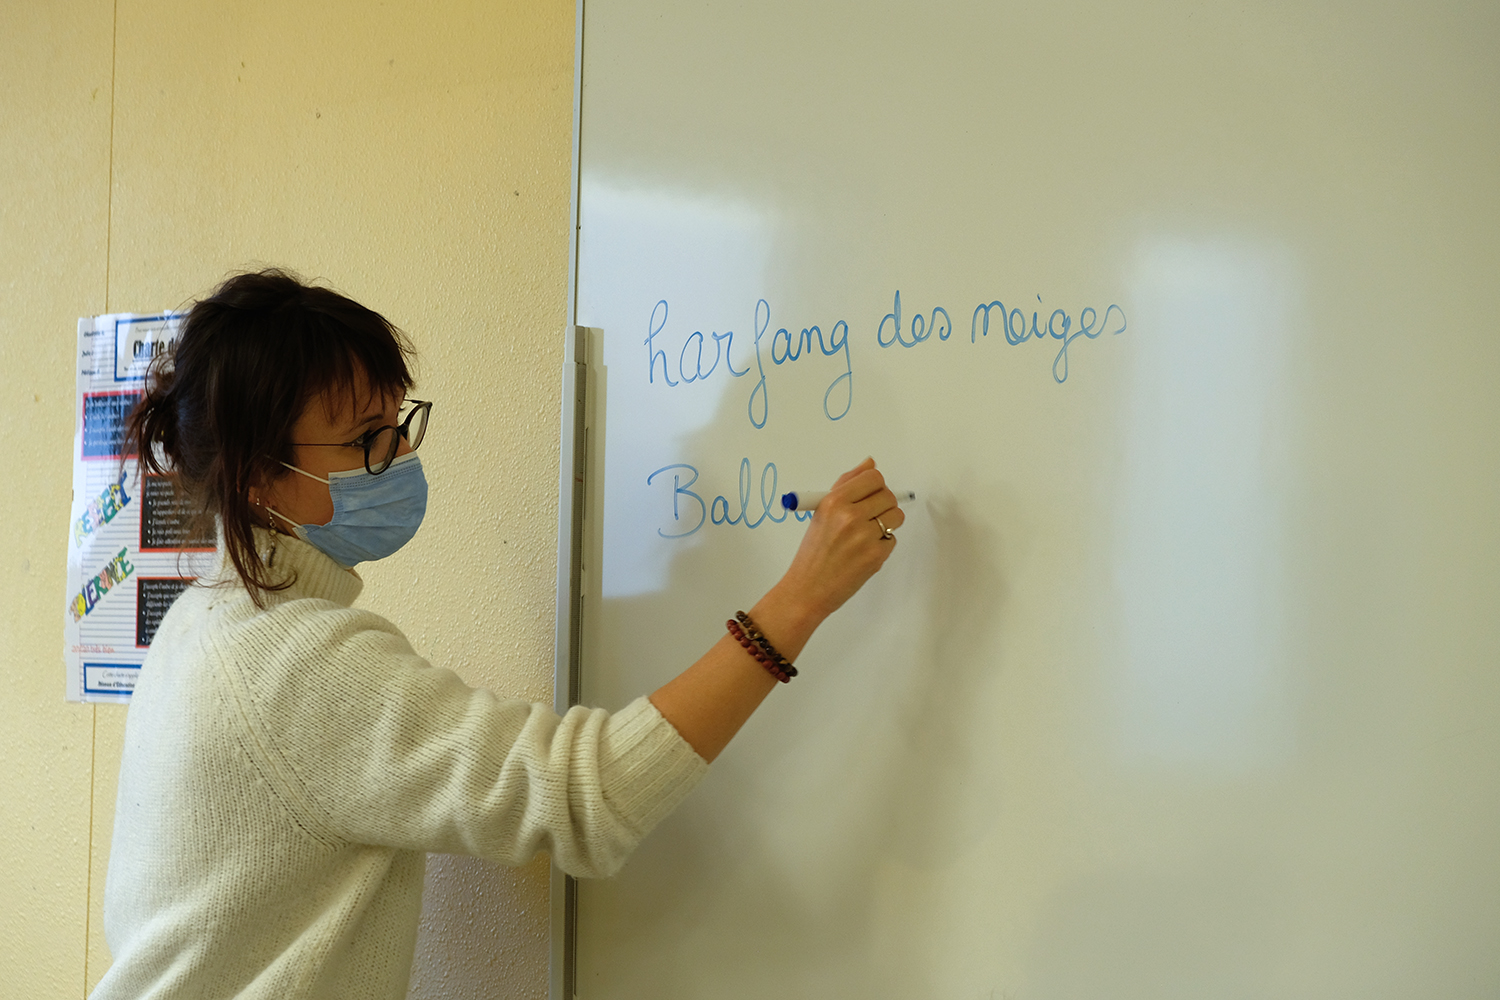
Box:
[123,268,413,607]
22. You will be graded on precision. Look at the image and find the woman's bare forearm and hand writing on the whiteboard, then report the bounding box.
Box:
[651,459,906,762]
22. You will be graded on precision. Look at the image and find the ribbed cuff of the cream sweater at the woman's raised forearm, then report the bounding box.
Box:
[599,697,708,837]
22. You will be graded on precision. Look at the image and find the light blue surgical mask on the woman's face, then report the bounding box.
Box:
[270,451,428,567]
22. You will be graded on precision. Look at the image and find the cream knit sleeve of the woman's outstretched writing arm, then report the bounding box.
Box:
[218,601,708,877]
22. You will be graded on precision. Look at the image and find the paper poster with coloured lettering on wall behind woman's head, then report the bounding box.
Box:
[63,313,213,702]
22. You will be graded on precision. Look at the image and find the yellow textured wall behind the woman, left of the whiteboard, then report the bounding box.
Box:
[0,0,575,997]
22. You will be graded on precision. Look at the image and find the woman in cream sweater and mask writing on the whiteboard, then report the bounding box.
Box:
[93,270,905,1000]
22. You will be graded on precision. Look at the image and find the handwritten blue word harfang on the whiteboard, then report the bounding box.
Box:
[645,298,854,427]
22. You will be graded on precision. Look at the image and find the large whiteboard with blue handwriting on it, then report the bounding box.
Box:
[564,0,1500,1000]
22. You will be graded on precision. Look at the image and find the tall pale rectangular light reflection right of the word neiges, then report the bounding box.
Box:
[1115,240,1298,774]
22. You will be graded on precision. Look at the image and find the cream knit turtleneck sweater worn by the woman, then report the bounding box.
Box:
[93,527,707,1000]
